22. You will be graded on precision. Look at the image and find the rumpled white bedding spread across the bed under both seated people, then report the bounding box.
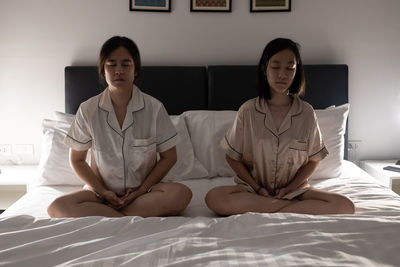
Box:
[0,162,400,266]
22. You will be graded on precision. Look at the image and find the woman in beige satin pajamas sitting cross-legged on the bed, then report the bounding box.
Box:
[206,38,354,215]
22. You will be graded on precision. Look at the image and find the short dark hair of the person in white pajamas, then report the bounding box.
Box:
[97,36,141,81]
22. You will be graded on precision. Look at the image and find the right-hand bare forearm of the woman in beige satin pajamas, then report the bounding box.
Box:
[275,159,319,198]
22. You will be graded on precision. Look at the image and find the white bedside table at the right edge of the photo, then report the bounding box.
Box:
[361,160,400,195]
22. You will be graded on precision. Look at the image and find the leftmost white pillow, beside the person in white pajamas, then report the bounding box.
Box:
[36,119,84,185]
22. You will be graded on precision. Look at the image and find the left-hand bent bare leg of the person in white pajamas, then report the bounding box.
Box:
[47,190,124,218]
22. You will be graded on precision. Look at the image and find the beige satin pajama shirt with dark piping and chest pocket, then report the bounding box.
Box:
[221,97,328,199]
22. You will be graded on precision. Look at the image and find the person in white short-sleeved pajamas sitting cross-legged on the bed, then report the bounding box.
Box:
[48,36,192,217]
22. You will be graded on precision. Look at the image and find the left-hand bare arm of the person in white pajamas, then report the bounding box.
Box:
[69,149,122,208]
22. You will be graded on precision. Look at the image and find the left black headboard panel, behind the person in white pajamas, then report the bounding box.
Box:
[65,66,207,115]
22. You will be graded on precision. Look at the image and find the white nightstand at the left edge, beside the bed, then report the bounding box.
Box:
[0,165,37,213]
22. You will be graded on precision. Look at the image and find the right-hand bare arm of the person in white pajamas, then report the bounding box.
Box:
[122,146,177,207]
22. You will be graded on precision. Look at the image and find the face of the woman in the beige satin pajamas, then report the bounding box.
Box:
[266,49,297,95]
